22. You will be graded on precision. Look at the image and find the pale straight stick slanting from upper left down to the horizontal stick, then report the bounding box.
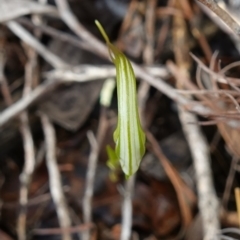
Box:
[6,21,69,68]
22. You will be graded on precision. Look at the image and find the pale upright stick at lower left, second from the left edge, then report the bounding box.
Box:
[40,113,72,240]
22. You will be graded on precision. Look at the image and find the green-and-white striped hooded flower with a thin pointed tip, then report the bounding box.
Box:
[95,21,145,177]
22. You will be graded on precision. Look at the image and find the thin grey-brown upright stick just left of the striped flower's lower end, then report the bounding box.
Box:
[82,131,99,240]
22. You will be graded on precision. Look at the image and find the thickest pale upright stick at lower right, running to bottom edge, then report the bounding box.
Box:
[175,68,220,240]
